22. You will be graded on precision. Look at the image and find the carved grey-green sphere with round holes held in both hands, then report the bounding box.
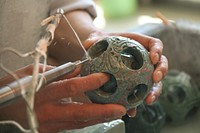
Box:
[81,36,154,109]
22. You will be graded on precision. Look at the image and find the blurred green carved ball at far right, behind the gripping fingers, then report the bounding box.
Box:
[159,70,200,124]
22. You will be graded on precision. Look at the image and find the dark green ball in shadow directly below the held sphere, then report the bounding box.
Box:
[122,102,165,133]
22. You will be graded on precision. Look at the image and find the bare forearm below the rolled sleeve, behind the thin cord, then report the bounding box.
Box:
[48,10,99,64]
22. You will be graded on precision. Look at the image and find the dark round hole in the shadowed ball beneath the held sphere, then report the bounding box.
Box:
[142,105,157,123]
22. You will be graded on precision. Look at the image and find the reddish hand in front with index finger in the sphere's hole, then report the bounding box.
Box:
[0,66,126,133]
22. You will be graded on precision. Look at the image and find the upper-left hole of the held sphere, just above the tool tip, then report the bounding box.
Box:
[88,40,109,59]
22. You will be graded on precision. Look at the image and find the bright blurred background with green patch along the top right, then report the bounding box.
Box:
[94,0,200,32]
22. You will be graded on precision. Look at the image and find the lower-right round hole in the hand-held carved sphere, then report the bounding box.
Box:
[128,84,148,103]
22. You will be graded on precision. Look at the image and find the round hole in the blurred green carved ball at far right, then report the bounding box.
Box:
[167,85,186,103]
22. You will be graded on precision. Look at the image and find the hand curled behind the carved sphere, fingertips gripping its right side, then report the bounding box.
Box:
[84,32,168,116]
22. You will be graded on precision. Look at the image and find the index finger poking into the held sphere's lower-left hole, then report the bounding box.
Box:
[37,73,109,102]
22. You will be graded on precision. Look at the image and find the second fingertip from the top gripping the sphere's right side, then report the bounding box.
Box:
[153,55,168,83]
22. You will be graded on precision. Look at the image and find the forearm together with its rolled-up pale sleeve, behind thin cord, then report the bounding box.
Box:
[48,0,97,64]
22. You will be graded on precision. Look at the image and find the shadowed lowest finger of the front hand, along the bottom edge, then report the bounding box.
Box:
[40,118,118,133]
